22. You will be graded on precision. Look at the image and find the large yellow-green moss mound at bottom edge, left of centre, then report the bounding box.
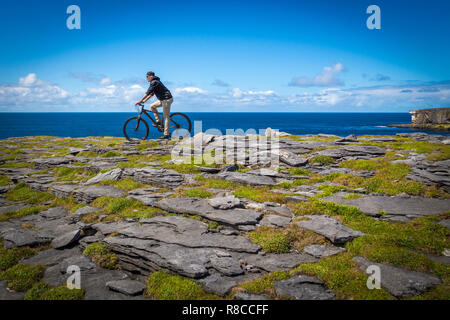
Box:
[145,270,217,300]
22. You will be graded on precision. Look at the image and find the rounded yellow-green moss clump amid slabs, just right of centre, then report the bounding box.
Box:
[248,227,291,253]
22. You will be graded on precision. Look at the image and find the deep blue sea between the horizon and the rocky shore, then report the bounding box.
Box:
[0,112,450,139]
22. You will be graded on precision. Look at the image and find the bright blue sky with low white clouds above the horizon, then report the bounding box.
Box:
[0,0,450,112]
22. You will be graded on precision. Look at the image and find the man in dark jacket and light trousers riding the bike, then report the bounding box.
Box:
[136,71,173,139]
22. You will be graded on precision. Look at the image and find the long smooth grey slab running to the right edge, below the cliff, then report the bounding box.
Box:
[323,192,450,217]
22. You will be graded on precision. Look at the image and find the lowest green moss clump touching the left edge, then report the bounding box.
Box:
[0,264,45,292]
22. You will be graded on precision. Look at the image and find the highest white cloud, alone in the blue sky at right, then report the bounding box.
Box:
[289,62,344,87]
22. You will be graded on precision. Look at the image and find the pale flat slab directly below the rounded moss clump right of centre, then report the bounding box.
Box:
[244,253,317,272]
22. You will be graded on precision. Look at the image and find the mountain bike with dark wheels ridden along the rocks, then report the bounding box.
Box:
[123,103,191,141]
